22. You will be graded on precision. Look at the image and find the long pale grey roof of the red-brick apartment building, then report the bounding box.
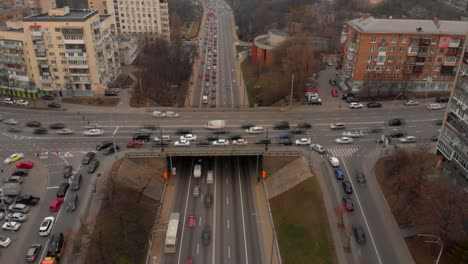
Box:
[346,17,468,35]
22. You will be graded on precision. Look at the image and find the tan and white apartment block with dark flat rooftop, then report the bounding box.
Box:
[15,7,120,95]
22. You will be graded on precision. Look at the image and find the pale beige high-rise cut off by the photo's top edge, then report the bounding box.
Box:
[113,0,170,41]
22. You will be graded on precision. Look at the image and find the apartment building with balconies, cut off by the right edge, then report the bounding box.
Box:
[437,35,468,180]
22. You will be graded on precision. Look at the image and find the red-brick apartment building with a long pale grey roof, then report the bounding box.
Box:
[340,17,468,96]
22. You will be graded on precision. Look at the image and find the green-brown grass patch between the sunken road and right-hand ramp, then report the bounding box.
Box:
[270,177,337,263]
